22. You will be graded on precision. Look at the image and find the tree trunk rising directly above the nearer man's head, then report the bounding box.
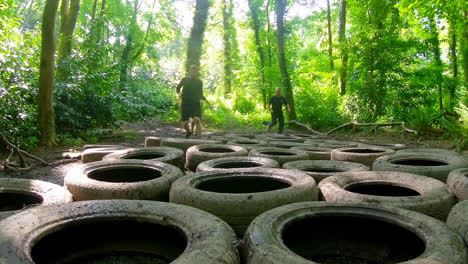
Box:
[185,0,210,72]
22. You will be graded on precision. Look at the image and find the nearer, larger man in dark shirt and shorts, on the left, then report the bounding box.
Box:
[177,65,209,138]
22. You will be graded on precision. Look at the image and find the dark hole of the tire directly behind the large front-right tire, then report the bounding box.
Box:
[345,182,421,197]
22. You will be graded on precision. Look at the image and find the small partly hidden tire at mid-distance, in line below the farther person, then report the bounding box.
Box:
[249,148,309,165]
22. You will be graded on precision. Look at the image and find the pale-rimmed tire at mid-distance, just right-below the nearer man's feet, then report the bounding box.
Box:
[185,144,249,171]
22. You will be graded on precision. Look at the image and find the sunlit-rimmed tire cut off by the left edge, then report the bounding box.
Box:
[0,178,73,220]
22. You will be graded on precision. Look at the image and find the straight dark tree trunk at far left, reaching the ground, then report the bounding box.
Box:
[38,0,59,146]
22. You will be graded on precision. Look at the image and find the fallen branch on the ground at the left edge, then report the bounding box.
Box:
[0,132,78,171]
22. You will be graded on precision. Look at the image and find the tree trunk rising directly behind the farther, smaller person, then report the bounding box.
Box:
[276,0,297,120]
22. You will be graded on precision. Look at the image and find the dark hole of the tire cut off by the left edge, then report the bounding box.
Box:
[0,190,44,212]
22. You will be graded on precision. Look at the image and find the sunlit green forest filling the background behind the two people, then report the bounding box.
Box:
[0,0,468,148]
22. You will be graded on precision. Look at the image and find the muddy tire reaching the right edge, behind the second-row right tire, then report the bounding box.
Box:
[372,149,467,182]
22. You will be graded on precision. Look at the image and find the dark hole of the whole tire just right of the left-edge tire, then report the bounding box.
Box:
[88,167,162,182]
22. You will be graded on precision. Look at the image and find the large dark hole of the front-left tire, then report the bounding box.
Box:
[31,218,187,264]
